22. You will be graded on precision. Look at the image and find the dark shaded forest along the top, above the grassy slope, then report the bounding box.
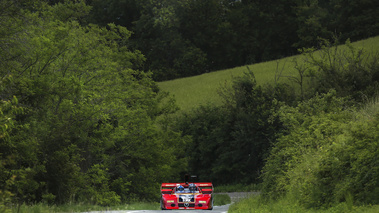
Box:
[87,0,379,81]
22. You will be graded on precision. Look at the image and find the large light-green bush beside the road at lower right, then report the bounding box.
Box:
[262,92,379,208]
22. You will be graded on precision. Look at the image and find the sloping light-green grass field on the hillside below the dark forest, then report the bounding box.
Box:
[158,36,379,111]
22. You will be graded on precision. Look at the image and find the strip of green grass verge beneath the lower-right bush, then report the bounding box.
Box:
[228,196,379,213]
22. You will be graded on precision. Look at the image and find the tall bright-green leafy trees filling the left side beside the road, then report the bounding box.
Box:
[0,0,186,207]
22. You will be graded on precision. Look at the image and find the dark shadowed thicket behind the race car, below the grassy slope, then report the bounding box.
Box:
[173,71,294,185]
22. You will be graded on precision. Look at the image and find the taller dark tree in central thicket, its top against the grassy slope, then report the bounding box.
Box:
[215,71,280,183]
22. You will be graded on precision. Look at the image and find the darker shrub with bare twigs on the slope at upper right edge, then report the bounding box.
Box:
[303,40,379,102]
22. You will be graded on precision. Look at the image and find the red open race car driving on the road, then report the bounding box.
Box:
[161,182,213,210]
